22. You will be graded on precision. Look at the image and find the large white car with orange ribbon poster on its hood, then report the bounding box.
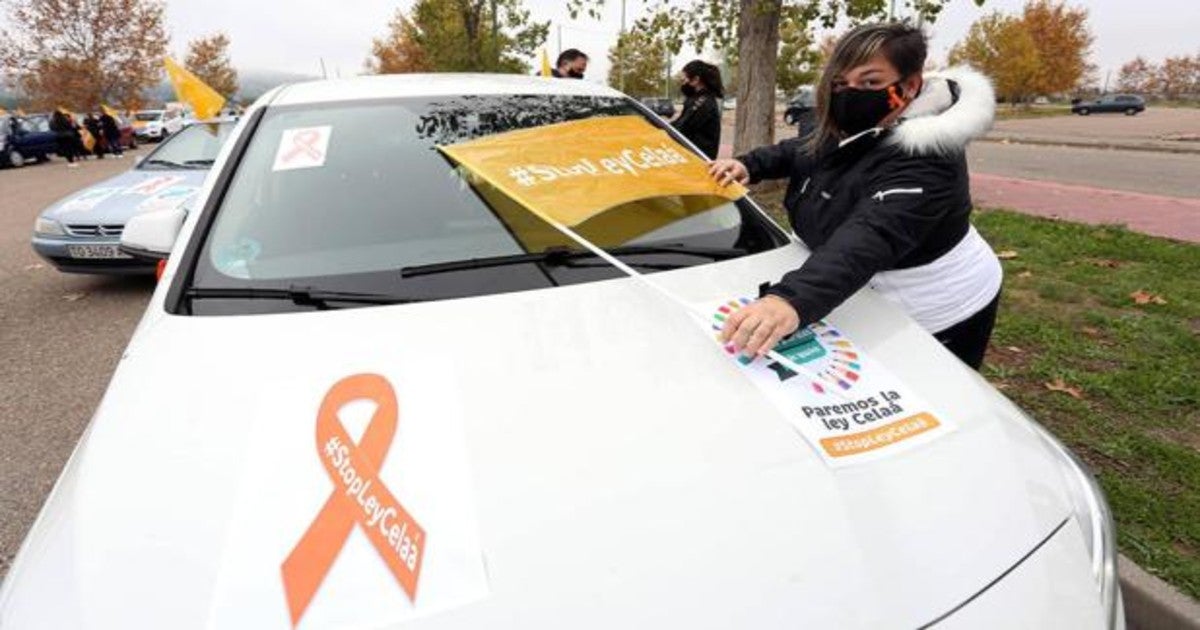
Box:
[0,74,1124,629]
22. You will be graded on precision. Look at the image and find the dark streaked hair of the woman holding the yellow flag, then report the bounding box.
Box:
[809,22,929,152]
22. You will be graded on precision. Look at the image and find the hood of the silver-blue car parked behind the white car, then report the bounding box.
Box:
[42,168,209,224]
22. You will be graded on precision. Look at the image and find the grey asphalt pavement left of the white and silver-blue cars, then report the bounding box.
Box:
[0,152,154,575]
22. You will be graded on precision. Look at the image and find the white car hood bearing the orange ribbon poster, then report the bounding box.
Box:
[0,247,1085,629]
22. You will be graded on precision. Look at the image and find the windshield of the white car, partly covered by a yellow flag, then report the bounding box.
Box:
[184,95,787,314]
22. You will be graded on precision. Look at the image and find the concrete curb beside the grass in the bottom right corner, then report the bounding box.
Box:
[1117,553,1200,630]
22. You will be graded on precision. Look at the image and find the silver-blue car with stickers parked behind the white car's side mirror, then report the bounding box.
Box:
[31,121,234,274]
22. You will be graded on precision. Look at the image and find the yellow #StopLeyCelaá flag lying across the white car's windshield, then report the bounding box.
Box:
[439,116,746,250]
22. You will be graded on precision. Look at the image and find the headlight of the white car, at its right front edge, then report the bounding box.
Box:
[1030,419,1124,629]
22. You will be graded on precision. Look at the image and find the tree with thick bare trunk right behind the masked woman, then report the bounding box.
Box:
[568,0,983,158]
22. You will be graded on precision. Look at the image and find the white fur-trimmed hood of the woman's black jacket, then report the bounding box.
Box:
[889,66,996,155]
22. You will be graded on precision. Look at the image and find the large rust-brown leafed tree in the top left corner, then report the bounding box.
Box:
[0,0,167,108]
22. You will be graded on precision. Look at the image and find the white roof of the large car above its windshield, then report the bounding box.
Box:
[271,73,624,106]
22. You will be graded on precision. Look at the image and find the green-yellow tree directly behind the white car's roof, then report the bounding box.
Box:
[366,0,550,73]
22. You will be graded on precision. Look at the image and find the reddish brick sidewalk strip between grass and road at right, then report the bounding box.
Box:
[971,173,1200,242]
